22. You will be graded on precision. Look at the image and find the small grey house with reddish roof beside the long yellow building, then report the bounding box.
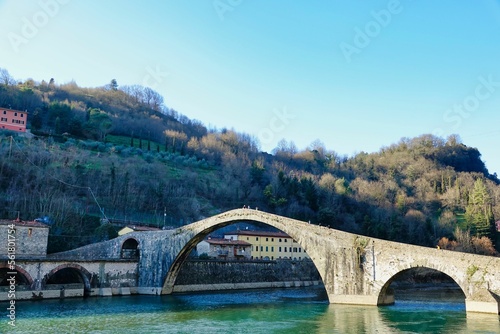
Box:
[196,238,252,260]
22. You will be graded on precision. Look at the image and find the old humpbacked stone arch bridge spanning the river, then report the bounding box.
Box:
[3,209,500,314]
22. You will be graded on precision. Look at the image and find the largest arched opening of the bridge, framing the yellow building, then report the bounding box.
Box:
[162,220,327,301]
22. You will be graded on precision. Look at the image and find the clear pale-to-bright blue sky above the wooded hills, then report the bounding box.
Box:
[0,0,500,174]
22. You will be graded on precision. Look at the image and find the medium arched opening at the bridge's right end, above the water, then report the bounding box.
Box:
[378,267,466,309]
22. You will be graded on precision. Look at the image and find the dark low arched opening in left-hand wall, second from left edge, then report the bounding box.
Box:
[42,264,91,296]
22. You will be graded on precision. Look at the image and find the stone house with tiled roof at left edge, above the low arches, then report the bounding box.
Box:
[0,219,49,257]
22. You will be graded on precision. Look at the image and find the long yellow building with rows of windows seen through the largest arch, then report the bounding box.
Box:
[224,230,309,260]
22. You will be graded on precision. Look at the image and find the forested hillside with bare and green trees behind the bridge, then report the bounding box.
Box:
[0,69,500,255]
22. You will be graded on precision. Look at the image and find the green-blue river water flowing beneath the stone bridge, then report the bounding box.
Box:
[0,287,500,334]
